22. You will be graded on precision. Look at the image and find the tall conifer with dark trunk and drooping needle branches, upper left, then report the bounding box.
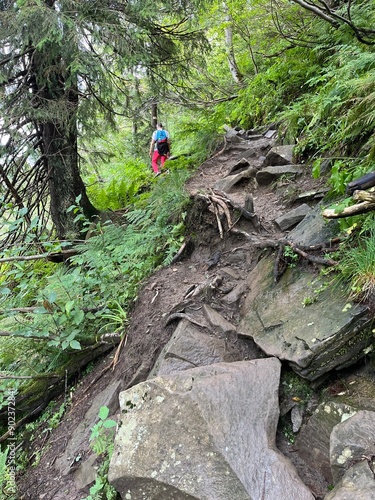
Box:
[0,0,206,238]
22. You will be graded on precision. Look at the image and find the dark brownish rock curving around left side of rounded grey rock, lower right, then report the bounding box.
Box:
[295,401,356,484]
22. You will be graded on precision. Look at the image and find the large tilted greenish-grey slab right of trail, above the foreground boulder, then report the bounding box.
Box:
[238,258,371,380]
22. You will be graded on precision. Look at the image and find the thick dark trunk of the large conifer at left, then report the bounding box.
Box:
[33,7,99,239]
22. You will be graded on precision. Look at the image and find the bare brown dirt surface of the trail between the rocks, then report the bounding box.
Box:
[17,136,328,500]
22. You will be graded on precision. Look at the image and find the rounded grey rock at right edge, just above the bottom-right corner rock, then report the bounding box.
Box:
[330,410,375,486]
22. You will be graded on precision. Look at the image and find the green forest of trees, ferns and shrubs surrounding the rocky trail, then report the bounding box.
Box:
[0,0,375,496]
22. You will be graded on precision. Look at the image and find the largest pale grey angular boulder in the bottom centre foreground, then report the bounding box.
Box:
[109,358,313,500]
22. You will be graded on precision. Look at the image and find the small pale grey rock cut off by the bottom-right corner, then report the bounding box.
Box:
[324,460,375,500]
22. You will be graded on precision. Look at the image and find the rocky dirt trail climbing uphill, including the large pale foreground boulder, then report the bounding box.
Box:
[15,131,375,500]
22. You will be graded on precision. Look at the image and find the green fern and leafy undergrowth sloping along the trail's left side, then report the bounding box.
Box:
[0,168,190,436]
